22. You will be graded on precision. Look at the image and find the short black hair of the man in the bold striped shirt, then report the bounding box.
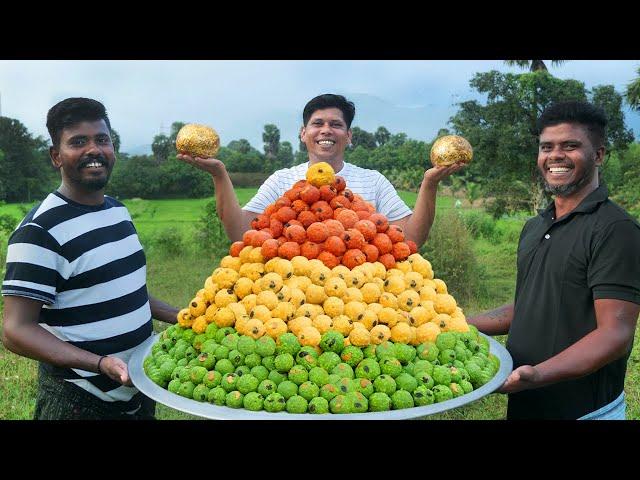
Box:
[47,97,111,147]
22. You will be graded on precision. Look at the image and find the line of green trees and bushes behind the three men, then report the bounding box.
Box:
[0,67,640,217]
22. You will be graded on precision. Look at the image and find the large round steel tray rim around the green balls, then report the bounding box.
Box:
[128,334,513,420]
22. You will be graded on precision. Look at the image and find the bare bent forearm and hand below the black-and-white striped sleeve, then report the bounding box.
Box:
[2,296,131,385]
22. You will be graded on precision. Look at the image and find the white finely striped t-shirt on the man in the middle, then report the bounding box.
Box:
[242,162,412,221]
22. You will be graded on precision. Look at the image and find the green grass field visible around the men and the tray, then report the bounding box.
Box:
[0,192,640,420]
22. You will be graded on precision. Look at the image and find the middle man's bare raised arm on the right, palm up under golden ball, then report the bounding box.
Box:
[398,163,464,248]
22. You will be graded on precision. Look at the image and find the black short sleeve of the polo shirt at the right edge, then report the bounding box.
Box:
[587,220,640,304]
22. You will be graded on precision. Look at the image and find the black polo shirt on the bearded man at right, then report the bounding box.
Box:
[506,186,640,419]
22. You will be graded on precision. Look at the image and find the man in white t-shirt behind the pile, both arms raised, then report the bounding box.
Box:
[177,94,464,247]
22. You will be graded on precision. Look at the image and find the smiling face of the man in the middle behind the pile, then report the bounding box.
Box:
[300,108,351,162]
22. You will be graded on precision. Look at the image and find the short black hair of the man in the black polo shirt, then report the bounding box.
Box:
[536,101,607,149]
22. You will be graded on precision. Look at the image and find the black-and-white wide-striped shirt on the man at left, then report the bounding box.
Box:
[2,192,152,412]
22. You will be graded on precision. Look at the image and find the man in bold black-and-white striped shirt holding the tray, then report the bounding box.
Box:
[2,98,178,419]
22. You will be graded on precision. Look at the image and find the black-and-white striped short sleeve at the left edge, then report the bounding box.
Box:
[2,223,62,304]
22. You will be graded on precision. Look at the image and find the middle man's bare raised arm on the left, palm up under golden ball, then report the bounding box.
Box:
[176,153,256,242]
